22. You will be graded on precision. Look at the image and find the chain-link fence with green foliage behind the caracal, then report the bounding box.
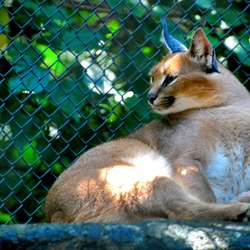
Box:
[0,0,250,224]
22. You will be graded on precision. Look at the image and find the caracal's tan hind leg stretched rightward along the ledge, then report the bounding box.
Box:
[135,177,250,221]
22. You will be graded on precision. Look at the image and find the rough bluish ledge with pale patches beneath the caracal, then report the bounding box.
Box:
[0,221,250,250]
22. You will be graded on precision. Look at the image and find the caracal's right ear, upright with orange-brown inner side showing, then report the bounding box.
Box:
[189,28,219,73]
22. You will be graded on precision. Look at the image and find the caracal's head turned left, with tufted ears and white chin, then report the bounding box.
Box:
[148,21,220,115]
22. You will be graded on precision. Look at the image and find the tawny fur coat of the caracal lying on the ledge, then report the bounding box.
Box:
[45,26,250,222]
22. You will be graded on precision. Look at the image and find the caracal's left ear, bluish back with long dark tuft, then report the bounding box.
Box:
[161,18,188,54]
